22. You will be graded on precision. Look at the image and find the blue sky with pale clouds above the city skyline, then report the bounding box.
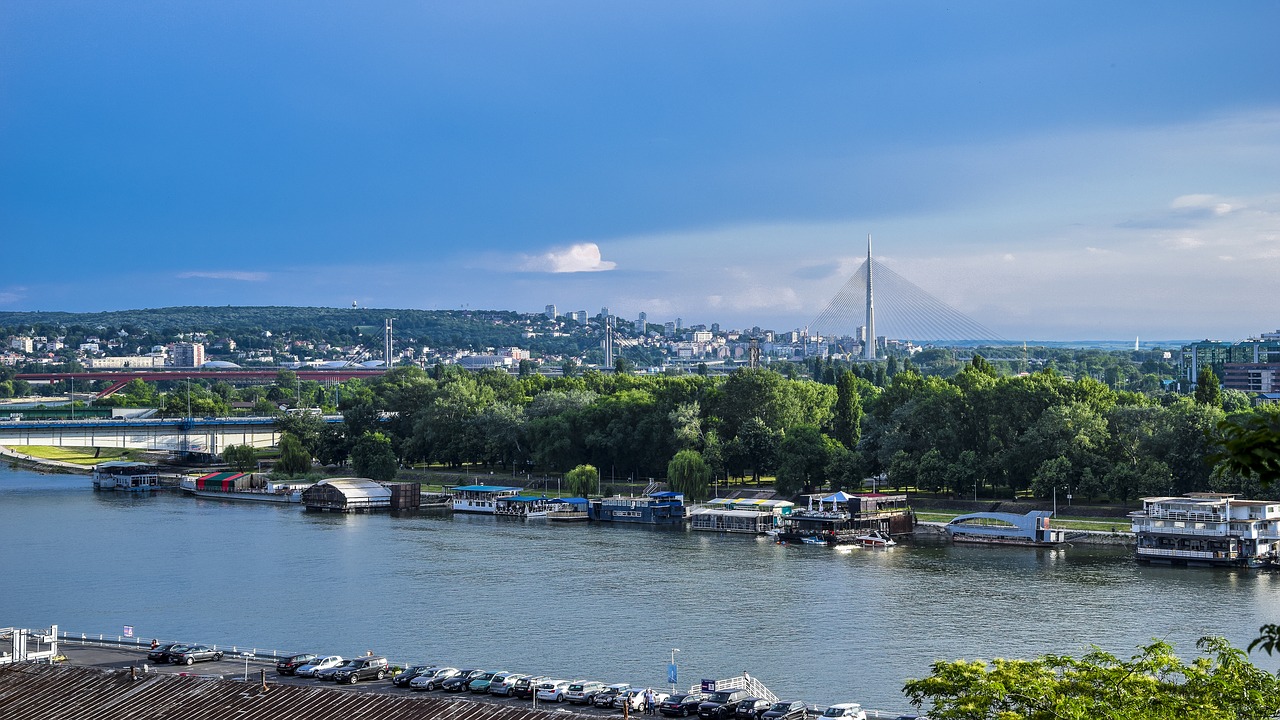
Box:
[0,0,1280,341]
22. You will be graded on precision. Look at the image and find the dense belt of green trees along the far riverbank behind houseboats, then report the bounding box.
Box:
[254,356,1276,502]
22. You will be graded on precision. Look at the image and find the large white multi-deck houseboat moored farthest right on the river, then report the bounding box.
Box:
[1129,492,1280,568]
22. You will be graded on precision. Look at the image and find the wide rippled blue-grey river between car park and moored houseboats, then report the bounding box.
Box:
[0,458,1280,708]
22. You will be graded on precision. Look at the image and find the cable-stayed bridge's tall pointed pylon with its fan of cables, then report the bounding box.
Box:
[809,237,1009,357]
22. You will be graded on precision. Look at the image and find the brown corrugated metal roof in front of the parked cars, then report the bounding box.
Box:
[0,664,588,720]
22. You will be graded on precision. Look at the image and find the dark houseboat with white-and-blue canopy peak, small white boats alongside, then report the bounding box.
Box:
[776,491,915,544]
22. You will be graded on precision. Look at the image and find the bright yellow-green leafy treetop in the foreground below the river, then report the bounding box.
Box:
[902,638,1280,720]
